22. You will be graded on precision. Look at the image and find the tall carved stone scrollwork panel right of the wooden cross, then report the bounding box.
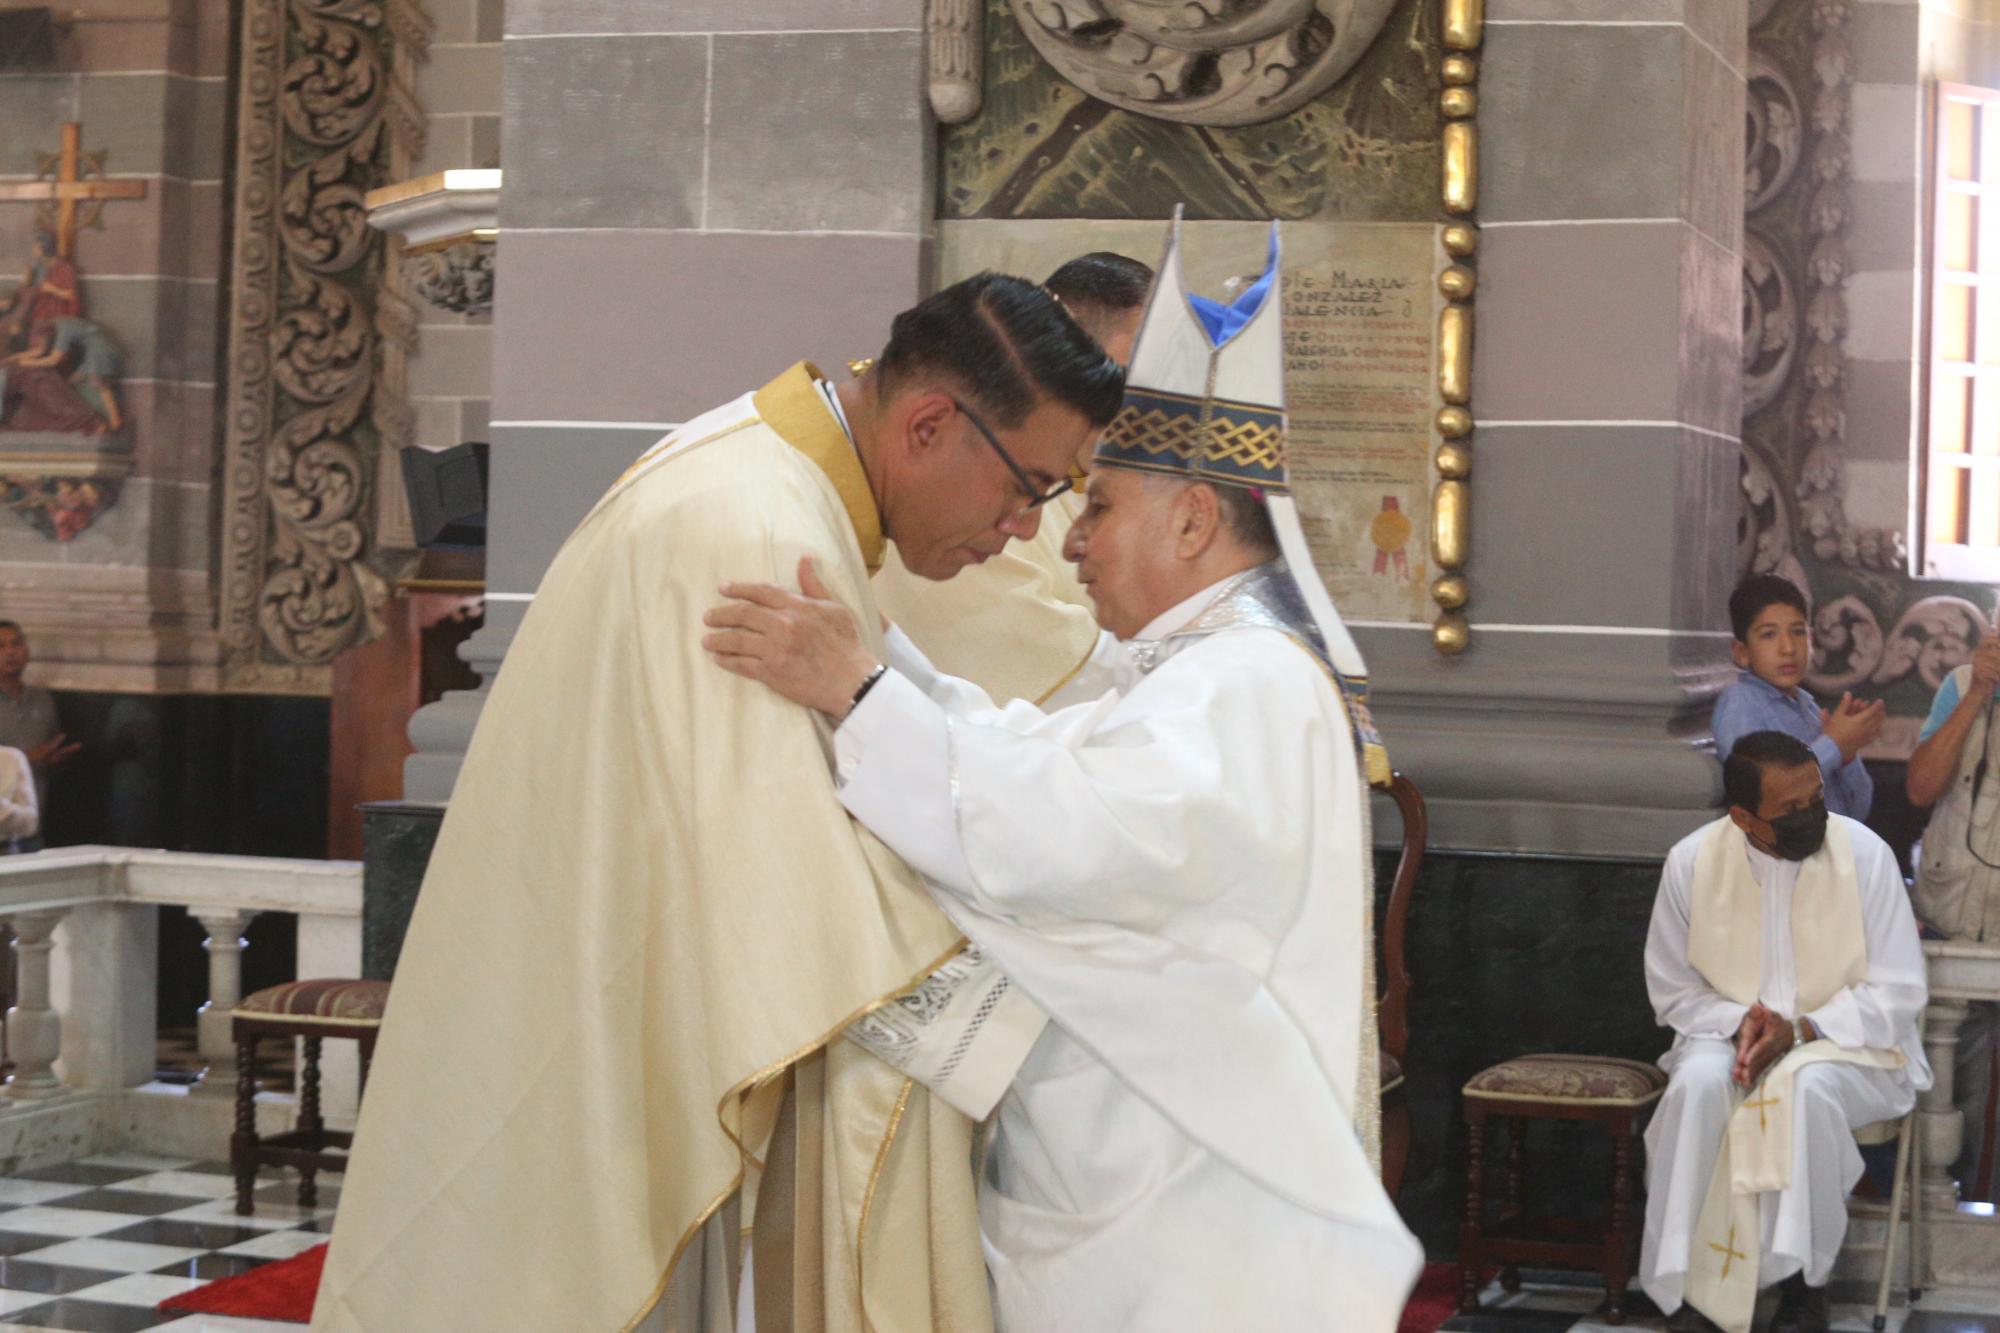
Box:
[220,0,430,693]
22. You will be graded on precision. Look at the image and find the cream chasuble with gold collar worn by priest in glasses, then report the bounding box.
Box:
[314,366,990,1333]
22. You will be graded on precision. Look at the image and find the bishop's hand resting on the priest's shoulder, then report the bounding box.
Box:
[702,556,878,721]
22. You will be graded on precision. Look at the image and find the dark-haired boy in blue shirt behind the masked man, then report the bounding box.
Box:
[1714,574,1888,819]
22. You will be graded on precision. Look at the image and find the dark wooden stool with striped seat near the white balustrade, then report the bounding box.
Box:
[230,979,388,1217]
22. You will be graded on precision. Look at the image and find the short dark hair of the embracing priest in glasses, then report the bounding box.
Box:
[874,272,1124,426]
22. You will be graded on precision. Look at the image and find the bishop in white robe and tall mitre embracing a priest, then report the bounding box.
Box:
[704,220,1422,1333]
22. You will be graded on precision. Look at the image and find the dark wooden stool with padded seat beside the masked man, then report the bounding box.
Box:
[1458,1055,1666,1323]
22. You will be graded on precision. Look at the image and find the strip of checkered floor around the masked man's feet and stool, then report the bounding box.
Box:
[1440,1271,2000,1333]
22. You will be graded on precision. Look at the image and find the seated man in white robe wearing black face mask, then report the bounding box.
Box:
[1640,731,1930,1333]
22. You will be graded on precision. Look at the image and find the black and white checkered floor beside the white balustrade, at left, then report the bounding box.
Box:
[0,1155,340,1333]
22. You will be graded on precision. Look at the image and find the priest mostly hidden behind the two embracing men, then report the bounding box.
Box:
[874,250,1152,705]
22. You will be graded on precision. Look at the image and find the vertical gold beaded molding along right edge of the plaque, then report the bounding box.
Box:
[1430,0,1486,656]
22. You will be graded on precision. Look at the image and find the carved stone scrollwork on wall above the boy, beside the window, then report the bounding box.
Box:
[1738,0,1990,759]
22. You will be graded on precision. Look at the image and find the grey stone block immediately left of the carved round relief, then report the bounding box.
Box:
[704,30,932,232]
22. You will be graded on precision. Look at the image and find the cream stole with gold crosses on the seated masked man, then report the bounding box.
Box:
[1656,817,1914,1333]
